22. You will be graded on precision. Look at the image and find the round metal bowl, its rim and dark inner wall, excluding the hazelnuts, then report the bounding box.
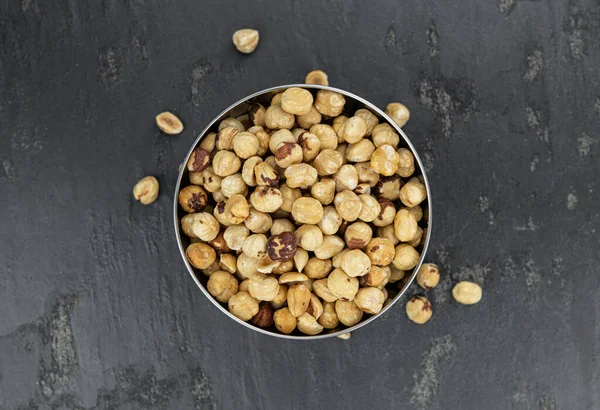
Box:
[173,84,433,340]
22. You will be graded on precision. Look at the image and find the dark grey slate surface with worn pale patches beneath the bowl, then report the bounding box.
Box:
[0,0,600,410]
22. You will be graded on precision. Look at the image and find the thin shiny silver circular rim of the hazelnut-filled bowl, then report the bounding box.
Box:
[173,84,433,340]
